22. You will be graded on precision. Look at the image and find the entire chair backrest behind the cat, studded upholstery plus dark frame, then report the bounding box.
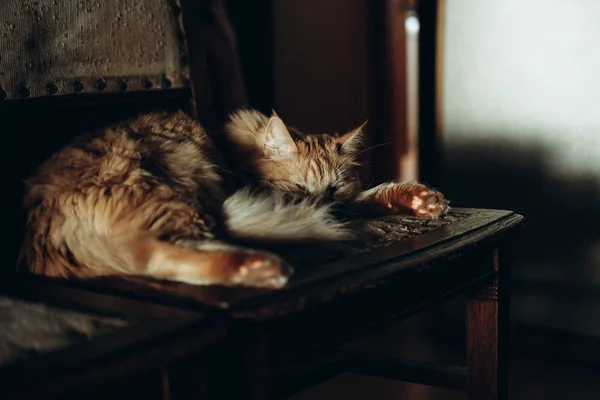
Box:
[0,0,243,271]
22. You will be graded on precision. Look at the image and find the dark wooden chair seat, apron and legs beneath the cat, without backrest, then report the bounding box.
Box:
[41,209,523,400]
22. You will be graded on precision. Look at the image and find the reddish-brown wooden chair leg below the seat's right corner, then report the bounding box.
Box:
[466,249,510,400]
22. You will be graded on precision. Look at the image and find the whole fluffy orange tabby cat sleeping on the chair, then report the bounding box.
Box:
[21,110,448,288]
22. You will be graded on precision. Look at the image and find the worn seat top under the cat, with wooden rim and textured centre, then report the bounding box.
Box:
[57,208,523,317]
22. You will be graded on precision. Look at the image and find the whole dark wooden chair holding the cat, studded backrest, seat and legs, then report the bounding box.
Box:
[0,0,523,400]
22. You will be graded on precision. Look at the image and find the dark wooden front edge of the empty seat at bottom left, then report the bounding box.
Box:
[0,317,227,396]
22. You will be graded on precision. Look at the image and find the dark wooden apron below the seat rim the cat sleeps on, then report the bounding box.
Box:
[258,222,518,365]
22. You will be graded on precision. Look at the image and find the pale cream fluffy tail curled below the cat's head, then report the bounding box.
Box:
[224,189,352,243]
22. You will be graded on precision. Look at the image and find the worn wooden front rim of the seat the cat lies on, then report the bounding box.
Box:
[44,209,522,318]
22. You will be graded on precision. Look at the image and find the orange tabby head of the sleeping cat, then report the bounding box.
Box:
[230,112,364,201]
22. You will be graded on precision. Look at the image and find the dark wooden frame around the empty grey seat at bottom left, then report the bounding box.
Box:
[0,280,226,399]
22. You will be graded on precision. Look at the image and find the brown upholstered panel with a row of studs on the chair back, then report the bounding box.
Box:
[0,0,190,100]
